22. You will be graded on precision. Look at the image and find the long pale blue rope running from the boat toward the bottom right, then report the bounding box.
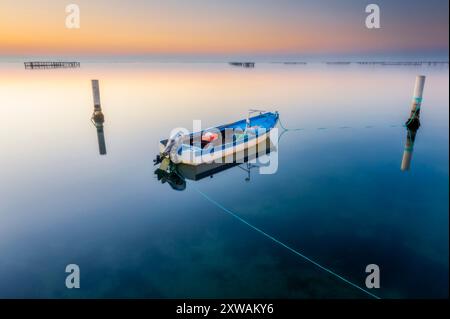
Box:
[190,183,381,299]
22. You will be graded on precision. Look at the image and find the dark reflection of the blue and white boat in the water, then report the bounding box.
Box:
[155,138,277,191]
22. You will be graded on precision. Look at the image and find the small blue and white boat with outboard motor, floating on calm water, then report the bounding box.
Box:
[155,111,279,166]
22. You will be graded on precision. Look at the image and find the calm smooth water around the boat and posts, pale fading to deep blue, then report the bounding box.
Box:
[0,63,449,298]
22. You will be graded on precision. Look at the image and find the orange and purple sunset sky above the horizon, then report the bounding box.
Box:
[0,0,449,57]
